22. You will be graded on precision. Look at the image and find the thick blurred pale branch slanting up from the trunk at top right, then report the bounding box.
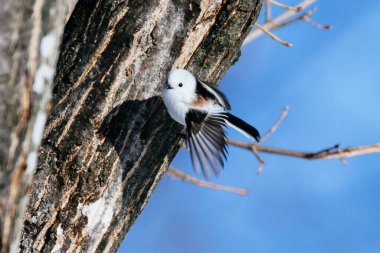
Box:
[243,0,317,45]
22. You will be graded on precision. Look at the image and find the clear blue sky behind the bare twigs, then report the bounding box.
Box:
[120,0,380,253]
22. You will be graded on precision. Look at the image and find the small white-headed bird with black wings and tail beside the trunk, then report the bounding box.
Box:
[162,69,260,179]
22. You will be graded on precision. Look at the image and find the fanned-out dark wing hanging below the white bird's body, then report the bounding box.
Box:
[186,109,227,179]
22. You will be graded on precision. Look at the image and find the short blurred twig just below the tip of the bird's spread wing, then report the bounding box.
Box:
[168,166,249,195]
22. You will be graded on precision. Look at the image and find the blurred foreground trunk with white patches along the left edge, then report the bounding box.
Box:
[0,0,75,252]
